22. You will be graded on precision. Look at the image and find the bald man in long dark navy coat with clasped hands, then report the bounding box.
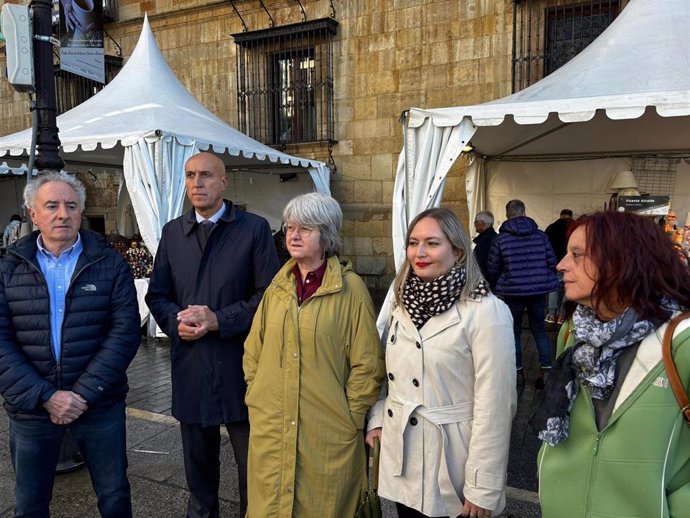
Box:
[146,153,278,517]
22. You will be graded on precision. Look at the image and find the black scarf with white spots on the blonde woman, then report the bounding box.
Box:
[402,263,489,329]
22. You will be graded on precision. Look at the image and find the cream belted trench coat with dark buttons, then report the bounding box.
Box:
[368,295,517,517]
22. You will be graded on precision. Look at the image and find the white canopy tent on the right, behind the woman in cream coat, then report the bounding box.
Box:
[393,0,690,267]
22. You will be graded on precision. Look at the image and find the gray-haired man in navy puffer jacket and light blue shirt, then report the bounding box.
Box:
[0,172,141,518]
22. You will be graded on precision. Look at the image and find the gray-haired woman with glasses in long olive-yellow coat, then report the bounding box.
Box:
[243,193,384,518]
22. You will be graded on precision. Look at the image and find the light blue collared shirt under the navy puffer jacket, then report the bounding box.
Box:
[36,234,84,361]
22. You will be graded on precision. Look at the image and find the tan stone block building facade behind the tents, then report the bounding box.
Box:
[0,0,548,288]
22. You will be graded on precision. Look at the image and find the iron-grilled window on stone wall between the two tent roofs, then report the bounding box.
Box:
[233,18,338,146]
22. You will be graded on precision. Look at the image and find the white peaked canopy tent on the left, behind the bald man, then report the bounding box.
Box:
[0,18,330,254]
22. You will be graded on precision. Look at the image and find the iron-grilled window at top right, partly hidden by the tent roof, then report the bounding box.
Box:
[513,0,628,92]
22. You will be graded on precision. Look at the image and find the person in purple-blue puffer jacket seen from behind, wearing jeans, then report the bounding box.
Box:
[487,200,559,388]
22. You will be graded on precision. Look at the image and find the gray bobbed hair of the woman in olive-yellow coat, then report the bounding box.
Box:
[283,192,343,257]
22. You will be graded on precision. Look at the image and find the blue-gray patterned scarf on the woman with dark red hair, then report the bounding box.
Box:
[530,299,680,446]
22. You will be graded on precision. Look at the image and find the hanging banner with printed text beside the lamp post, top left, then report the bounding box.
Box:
[60,0,105,83]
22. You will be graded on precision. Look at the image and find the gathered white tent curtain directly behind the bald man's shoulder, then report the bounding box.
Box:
[123,136,194,256]
